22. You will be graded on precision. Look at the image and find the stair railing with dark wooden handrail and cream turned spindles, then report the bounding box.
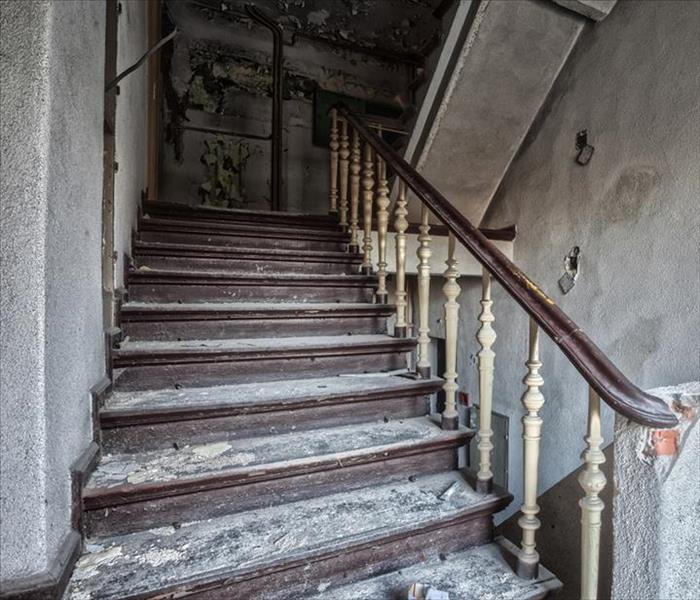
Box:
[330,104,677,600]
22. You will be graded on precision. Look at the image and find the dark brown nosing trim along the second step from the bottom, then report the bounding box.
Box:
[116,496,511,600]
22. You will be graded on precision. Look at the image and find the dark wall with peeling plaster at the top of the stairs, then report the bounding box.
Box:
[161,3,409,213]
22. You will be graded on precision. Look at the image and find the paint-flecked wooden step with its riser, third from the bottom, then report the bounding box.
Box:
[83,417,471,533]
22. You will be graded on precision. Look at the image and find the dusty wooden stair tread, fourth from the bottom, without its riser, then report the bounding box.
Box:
[100,374,443,426]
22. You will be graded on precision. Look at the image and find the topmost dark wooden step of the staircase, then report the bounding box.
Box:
[143,202,340,230]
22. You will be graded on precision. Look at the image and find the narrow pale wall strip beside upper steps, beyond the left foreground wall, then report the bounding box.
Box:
[114,0,148,288]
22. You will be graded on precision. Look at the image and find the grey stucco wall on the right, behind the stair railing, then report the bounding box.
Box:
[436,1,700,528]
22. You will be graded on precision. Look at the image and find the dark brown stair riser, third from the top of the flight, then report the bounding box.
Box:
[135,255,360,275]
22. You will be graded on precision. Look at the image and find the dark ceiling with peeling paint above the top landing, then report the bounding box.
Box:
[183,0,444,62]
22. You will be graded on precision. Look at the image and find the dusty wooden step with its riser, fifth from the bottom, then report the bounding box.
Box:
[112,335,416,390]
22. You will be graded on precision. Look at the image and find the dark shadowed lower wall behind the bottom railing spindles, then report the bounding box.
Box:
[496,444,614,600]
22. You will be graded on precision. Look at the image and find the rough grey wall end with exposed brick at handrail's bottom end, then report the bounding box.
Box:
[612,381,700,600]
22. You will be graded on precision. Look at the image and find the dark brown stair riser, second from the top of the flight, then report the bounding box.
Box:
[139,231,347,252]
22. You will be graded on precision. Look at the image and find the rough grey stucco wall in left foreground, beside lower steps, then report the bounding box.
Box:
[0,1,104,580]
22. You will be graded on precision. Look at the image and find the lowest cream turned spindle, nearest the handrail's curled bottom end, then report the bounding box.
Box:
[578,388,606,600]
